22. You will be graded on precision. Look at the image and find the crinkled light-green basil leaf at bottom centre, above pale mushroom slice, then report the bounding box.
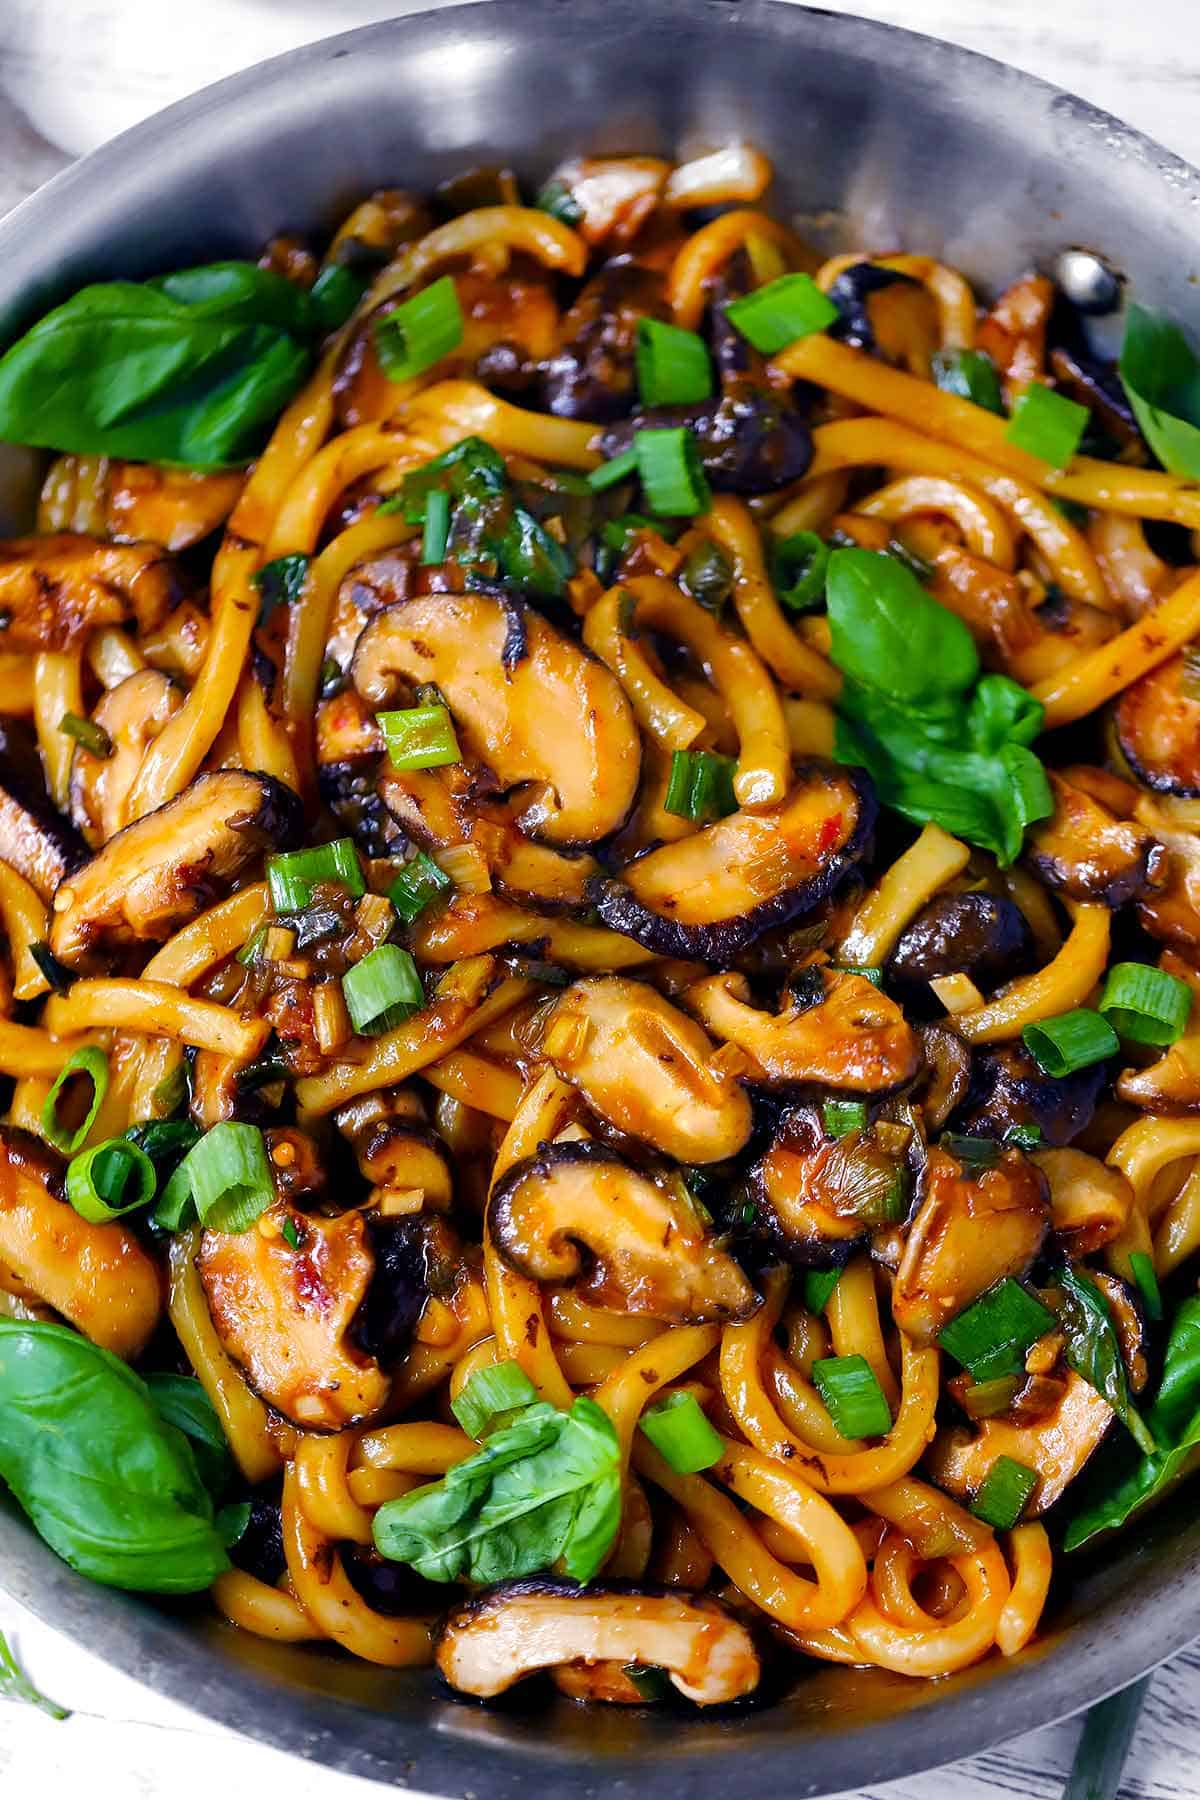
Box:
[374,1397,621,1582]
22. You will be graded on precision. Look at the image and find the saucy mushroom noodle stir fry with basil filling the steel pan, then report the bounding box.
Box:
[0,144,1200,1706]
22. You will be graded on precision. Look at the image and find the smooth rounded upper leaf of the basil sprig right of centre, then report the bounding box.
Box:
[826,549,979,704]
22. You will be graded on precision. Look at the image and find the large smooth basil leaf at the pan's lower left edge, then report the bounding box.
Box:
[0,1319,228,1593]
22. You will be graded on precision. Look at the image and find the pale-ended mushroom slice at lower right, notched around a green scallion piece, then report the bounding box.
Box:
[925,1370,1117,1517]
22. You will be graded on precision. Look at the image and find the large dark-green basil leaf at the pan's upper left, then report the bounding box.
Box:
[0,263,322,468]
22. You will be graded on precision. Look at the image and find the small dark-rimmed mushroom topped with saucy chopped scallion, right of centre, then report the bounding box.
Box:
[752,1107,910,1269]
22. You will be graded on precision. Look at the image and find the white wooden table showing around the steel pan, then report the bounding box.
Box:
[0,0,1200,1800]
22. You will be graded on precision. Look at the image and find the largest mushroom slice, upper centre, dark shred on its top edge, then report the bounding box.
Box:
[353,594,640,846]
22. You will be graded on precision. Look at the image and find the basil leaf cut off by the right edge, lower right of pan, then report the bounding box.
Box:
[1063,1298,1200,1550]
